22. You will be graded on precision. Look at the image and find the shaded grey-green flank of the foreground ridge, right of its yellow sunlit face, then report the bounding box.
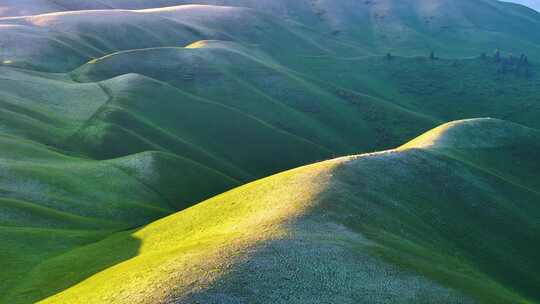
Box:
[174,149,540,304]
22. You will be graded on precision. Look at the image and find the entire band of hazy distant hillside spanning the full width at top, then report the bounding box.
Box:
[0,0,540,66]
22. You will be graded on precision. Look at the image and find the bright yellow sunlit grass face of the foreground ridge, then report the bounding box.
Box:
[42,161,341,303]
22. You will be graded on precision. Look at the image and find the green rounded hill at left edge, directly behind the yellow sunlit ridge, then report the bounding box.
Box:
[0,135,238,301]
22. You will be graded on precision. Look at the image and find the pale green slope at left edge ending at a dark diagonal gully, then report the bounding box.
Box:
[0,67,109,146]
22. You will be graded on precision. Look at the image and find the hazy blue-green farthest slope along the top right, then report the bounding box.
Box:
[183,0,540,57]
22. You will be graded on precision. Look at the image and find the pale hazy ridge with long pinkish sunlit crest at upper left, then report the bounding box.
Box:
[0,5,354,72]
